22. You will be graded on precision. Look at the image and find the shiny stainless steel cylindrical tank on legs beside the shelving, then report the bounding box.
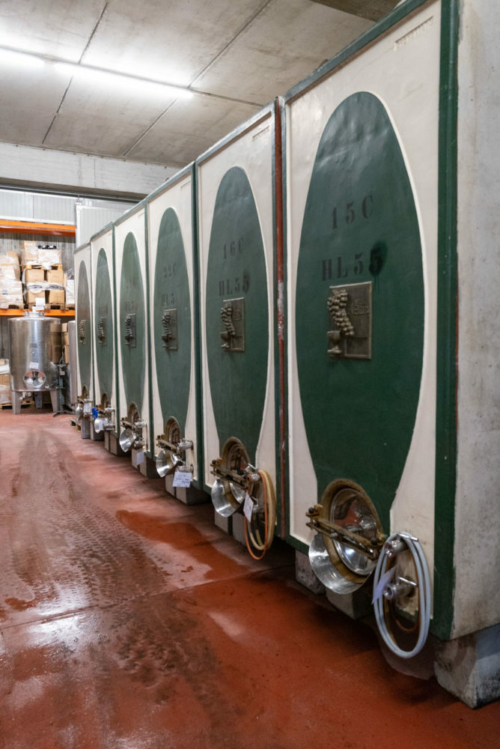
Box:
[9,312,62,413]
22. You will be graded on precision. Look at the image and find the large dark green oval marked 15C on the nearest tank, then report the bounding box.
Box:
[295,92,424,530]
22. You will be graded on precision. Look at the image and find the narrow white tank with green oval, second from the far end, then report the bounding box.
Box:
[90,226,119,448]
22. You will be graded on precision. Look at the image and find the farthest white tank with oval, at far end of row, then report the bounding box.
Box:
[74,244,94,439]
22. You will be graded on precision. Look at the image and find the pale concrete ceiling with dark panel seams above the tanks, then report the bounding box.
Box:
[0,0,372,167]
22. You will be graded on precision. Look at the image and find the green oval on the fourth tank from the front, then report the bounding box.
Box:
[119,232,146,416]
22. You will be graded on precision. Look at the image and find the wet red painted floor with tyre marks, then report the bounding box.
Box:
[0,411,500,749]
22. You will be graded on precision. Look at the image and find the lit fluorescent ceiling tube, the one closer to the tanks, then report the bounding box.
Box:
[54,61,193,99]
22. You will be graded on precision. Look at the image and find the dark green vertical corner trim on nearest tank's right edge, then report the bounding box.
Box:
[431,0,460,640]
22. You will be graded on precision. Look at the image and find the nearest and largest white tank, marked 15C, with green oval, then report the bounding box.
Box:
[284,0,500,706]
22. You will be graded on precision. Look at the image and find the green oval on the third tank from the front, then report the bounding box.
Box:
[153,208,191,435]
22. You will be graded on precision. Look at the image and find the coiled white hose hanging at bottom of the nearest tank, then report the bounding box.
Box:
[373,532,431,658]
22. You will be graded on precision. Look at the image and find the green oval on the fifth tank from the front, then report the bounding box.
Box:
[94,248,114,401]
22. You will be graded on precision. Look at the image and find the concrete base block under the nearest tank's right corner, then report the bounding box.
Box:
[434,624,500,708]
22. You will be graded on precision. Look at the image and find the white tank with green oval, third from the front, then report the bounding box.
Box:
[146,166,208,504]
